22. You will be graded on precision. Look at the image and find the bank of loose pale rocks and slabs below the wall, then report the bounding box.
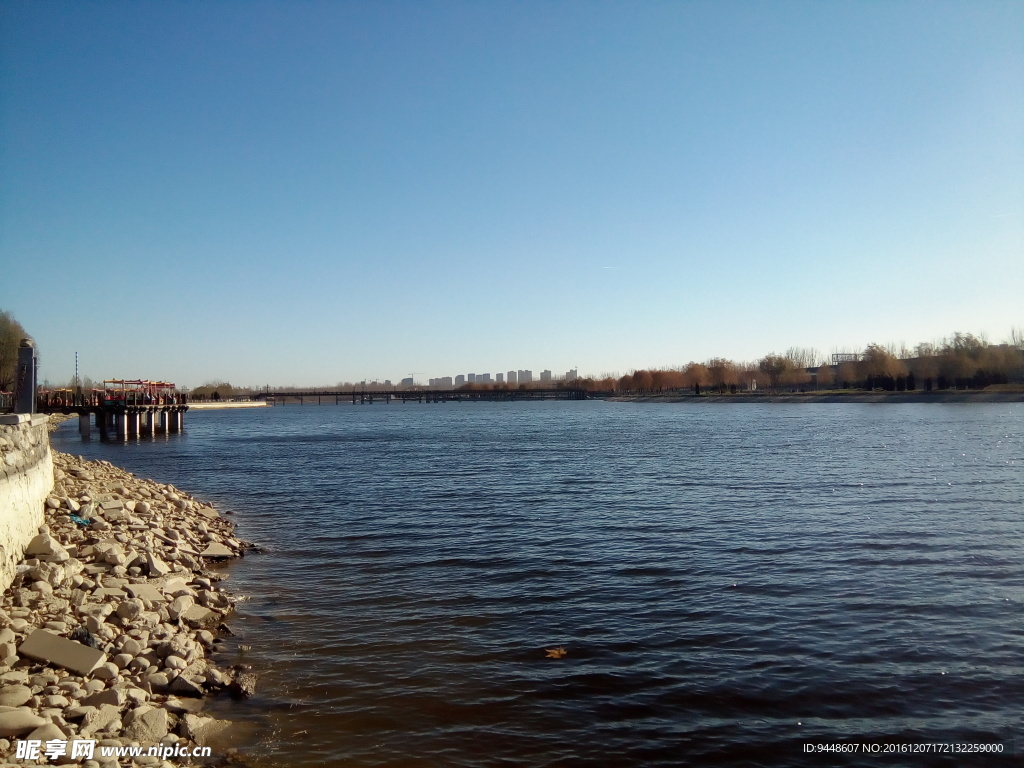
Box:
[0,452,255,768]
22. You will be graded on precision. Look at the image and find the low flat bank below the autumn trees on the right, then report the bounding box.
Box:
[606,391,1024,404]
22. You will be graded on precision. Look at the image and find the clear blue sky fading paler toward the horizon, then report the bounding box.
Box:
[0,0,1024,386]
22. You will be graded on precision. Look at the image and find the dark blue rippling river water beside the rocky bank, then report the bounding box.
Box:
[55,402,1024,767]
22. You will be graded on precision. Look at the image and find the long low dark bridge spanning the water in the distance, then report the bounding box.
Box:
[253,388,590,406]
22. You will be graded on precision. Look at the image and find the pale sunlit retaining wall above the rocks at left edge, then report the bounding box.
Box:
[0,414,53,590]
